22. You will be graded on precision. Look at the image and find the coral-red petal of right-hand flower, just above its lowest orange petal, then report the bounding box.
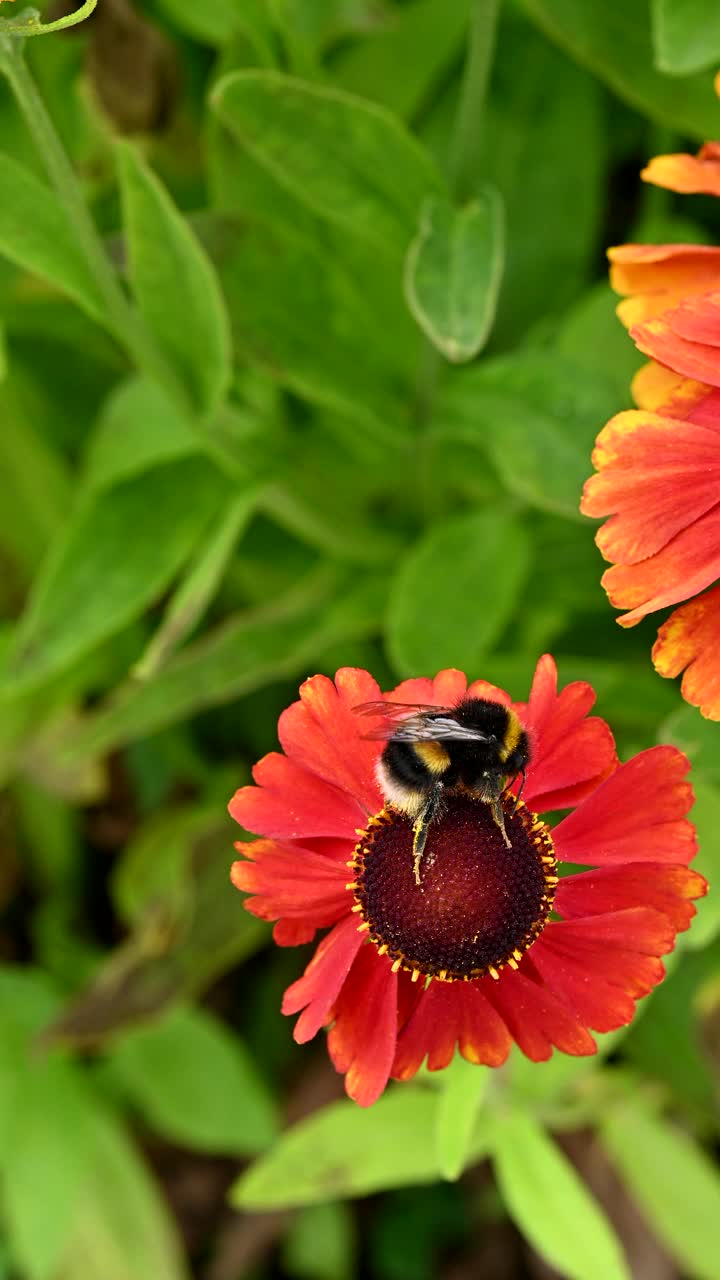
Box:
[602,499,720,627]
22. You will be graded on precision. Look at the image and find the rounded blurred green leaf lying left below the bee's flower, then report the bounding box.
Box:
[106,1007,277,1156]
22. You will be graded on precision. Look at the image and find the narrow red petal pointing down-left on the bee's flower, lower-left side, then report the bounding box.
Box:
[282,915,363,1044]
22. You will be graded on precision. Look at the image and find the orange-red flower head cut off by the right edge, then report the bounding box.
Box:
[582,104,720,719]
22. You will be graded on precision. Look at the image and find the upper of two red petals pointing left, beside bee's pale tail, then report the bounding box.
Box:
[228,751,366,840]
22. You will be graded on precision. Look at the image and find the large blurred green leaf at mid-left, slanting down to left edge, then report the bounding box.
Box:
[9,460,227,686]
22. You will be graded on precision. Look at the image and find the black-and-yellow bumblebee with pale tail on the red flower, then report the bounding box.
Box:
[354,698,530,884]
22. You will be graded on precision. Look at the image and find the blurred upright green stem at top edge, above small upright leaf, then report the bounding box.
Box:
[448,0,502,201]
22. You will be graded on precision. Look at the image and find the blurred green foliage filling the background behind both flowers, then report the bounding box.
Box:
[0,0,720,1280]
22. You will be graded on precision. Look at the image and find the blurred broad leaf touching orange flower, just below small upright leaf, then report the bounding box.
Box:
[429,352,616,521]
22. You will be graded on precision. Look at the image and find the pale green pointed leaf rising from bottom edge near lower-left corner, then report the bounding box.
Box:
[58,1107,190,1280]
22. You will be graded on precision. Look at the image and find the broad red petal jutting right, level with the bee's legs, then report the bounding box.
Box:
[552,746,697,867]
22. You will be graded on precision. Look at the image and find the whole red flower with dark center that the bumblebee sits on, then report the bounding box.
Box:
[229,657,706,1106]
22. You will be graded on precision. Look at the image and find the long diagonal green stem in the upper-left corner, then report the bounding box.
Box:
[0,35,188,408]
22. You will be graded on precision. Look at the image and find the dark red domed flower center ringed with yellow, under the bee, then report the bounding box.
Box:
[351,794,557,982]
